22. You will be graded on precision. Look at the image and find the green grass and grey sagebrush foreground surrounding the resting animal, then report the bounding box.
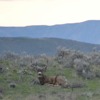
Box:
[0,48,100,100]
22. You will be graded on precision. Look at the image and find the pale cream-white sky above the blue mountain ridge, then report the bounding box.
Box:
[0,0,100,26]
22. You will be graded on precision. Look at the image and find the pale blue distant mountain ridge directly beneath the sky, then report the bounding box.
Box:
[0,20,100,44]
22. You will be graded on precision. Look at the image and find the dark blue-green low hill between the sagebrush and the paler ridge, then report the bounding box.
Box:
[0,38,100,55]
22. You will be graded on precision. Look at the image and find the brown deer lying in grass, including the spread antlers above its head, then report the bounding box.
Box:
[31,63,68,86]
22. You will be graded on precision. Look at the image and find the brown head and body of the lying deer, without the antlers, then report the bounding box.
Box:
[38,72,68,86]
